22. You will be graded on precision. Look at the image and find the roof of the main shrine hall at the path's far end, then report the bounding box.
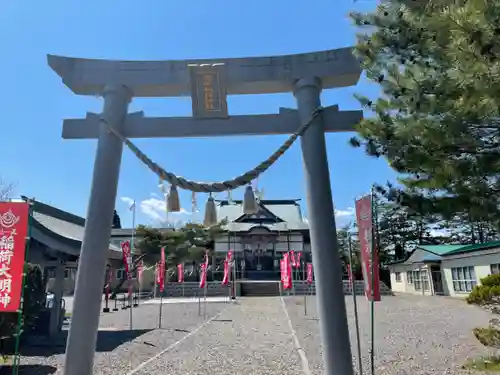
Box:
[217,199,309,232]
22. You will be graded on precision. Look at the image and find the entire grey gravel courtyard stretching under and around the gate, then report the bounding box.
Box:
[21,295,491,375]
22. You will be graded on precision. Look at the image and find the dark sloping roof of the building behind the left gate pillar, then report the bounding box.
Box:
[22,196,122,259]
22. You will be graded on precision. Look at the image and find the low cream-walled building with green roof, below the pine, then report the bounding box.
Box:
[388,241,500,297]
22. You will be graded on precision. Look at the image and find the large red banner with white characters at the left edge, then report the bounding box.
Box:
[0,202,29,312]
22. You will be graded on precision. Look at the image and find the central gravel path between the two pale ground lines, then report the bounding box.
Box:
[132,298,303,375]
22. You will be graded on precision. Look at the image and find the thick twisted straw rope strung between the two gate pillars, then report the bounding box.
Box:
[101,107,322,194]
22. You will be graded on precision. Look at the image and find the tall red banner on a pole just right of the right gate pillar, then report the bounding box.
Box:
[356,195,380,301]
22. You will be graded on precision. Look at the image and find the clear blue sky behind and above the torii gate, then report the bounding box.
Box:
[0,0,395,226]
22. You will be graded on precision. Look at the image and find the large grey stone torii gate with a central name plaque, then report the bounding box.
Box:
[48,48,362,375]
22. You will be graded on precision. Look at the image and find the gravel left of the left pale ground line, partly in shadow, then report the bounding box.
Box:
[20,303,229,375]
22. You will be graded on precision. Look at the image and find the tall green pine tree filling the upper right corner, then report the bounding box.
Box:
[352,0,500,229]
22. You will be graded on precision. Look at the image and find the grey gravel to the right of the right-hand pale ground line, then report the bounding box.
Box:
[285,295,492,375]
